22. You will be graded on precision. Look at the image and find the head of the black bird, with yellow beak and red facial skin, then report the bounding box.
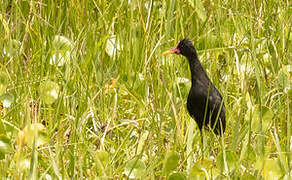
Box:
[162,39,196,56]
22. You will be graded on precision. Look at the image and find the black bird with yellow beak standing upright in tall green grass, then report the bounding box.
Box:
[163,39,226,135]
